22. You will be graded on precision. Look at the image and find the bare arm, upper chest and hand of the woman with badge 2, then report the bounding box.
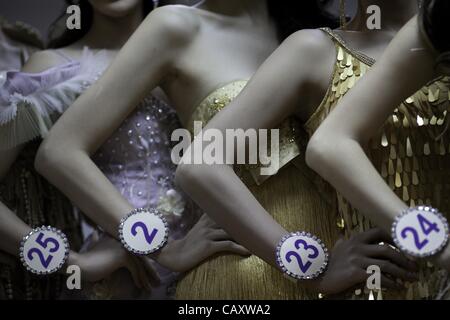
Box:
[36,0,277,271]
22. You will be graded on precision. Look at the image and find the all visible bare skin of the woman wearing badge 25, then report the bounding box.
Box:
[0,0,158,289]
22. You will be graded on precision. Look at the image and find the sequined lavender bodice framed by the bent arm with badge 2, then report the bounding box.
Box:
[90,96,202,299]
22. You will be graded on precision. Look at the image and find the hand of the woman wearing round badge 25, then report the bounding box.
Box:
[68,235,159,291]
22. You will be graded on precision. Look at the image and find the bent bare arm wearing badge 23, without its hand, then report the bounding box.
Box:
[176,30,340,265]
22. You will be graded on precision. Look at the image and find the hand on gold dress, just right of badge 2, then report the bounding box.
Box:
[151,214,250,272]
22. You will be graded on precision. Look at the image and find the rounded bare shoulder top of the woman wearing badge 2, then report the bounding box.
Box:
[143,5,200,41]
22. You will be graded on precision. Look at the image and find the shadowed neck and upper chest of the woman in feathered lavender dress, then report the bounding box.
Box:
[80,6,144,50]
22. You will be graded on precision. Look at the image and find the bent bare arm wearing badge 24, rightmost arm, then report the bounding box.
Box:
[307,18,450,266]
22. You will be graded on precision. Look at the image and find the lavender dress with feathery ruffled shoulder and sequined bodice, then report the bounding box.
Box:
[0,49,200,299]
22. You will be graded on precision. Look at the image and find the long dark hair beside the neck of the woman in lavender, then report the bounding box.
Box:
[47,0,153,48]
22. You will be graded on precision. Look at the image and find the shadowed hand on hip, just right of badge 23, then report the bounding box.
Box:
[304,229,418,294]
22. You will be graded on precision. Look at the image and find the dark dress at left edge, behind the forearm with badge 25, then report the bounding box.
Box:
[0,141,82,300]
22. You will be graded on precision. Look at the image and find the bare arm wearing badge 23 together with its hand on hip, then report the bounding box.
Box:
[177,30,415,294]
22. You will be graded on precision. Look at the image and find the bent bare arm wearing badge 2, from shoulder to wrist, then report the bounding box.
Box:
[36,10,187,237]
